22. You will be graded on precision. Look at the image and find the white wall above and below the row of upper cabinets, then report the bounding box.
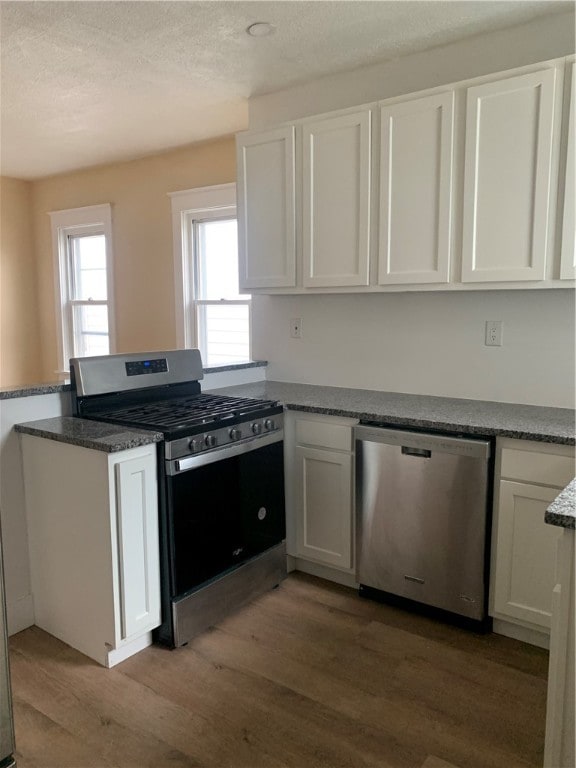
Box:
[249,9,575,408]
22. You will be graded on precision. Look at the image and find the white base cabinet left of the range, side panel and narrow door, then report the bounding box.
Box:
[21,434,160,667]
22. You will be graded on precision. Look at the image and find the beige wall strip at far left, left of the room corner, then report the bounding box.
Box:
[0,177,42,387]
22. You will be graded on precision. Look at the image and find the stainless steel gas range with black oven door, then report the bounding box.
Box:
[70,349,286,647]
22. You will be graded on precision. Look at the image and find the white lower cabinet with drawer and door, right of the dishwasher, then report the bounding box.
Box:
[490,439,574,639]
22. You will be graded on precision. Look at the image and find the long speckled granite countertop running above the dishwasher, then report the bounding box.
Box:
[205,381,576,445]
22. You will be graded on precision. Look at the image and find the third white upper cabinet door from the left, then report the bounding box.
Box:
[378,92,454,285]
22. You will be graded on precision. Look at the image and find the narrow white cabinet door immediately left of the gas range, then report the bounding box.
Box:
[115,454,160,640]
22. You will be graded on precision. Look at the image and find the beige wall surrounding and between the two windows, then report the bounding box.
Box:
[32,137,236,381]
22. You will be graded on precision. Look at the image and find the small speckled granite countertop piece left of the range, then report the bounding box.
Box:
[14,416,163,453]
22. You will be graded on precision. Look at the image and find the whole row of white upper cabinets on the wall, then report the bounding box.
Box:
[237,57,576,294]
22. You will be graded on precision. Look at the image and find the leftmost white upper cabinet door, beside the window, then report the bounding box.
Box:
[236,126,296,291]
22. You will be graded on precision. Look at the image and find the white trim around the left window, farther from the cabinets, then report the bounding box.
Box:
[48,203,116,377]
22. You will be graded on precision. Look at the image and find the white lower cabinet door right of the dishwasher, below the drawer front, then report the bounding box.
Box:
[494,480,562,629]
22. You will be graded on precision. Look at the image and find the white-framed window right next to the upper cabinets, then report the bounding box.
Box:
[171,184,251,366]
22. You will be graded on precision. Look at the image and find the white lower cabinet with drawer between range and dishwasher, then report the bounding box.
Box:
[285,412,356,575]
